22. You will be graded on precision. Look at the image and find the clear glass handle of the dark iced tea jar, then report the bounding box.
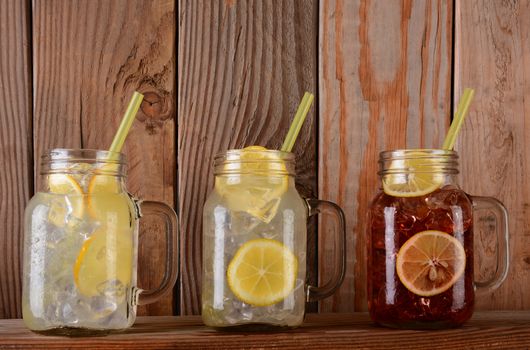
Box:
[471,196,510,294]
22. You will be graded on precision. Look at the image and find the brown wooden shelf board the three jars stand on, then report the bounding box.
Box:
[0,311,530,350]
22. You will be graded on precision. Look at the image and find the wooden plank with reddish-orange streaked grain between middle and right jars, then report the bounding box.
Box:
[319,0,453,311]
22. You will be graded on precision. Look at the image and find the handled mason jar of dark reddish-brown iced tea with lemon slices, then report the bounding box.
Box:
[367,149,509,328]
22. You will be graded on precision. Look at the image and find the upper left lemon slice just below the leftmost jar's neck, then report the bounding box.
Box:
[48,174,84,227]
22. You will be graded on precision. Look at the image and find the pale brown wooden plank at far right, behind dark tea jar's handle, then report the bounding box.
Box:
[455,0,530,309]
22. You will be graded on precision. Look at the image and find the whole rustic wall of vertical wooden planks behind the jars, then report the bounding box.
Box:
[0,0,530,318]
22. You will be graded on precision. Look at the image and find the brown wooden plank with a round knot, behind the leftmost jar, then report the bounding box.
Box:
[33,0,176,315]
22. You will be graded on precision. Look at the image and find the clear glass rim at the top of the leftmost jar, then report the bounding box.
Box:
[41,148,127,164]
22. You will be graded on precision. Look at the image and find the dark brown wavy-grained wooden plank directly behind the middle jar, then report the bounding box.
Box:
[178,0,318,314]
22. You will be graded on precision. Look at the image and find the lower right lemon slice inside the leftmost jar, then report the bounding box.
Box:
[74,228,133,297]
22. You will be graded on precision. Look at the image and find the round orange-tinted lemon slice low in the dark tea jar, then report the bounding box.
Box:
[396,231,466,297]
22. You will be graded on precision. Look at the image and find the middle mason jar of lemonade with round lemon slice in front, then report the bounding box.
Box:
[202,146,345,329]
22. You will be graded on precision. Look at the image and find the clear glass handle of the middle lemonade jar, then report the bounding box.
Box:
[305,198,346,302]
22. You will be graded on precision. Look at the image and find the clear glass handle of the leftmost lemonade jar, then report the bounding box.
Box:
[137,201,179,305]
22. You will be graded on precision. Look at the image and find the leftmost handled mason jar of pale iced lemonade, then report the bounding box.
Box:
[22,149,178,334]
